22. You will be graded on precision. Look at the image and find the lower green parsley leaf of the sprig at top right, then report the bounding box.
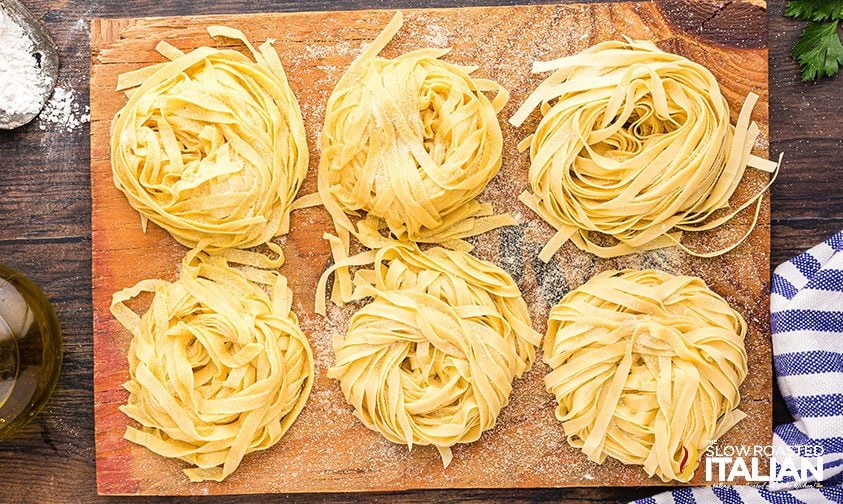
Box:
[793,21,843,81]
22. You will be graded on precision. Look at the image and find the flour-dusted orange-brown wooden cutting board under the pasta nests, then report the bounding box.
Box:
[91,2,772,494]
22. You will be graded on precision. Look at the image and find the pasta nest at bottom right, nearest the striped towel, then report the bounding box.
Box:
[544,270,747,482]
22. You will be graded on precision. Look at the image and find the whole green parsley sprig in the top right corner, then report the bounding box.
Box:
[785,0,843,81]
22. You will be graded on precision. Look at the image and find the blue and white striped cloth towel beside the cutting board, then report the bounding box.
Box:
[637,231,843,504]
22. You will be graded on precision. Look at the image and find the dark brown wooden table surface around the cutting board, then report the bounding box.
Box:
[0,0,843,503]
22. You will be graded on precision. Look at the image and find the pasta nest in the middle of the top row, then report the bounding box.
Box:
[319,12,514,249]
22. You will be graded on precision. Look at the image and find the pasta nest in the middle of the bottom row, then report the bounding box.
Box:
[328,242,540,467]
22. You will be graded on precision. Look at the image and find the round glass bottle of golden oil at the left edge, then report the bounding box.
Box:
[0,264,62,440]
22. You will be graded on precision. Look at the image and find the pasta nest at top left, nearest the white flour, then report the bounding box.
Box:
[111,26,308,249]
